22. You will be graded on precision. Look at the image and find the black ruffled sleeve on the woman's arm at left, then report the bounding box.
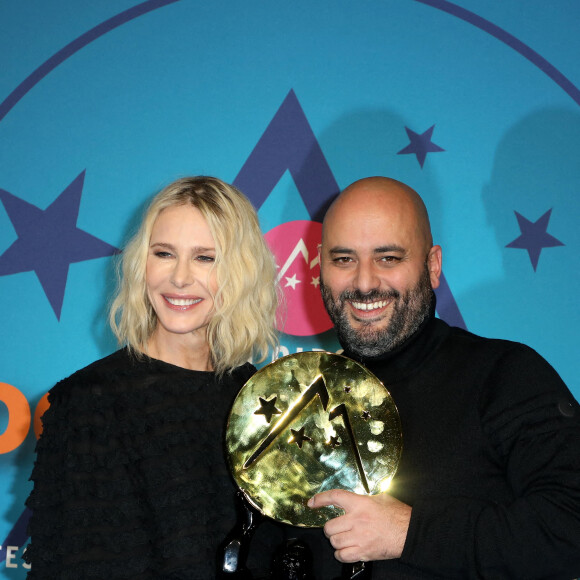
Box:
[24,375,153,580]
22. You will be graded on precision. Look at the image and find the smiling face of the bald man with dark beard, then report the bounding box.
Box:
[320,188,441,357]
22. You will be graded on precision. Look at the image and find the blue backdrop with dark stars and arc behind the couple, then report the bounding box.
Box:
[0,0,580,579]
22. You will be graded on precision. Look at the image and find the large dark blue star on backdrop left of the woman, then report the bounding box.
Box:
[0,171,119,320]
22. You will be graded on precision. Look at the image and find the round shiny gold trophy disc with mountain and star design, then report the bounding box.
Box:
[226,351,402,527]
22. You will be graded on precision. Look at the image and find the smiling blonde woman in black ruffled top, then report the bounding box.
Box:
[25,177,277,580]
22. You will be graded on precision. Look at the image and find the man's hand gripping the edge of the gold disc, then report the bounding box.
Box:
[308,489,411,563]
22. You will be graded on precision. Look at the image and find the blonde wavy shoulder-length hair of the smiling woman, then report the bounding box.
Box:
[109,176,279,374]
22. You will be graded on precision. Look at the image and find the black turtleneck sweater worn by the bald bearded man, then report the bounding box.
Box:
[345,316,580,580]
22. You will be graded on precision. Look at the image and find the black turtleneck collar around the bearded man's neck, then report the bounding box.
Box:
[342,300,449,382]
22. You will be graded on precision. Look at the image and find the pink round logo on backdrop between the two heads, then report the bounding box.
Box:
[265,220,332,336]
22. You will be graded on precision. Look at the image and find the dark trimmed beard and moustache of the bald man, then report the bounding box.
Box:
[320,266,434,358]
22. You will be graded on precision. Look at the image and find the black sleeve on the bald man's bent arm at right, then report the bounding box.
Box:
[402,345,580,580]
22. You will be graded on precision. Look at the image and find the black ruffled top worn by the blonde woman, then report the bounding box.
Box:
[24,349,266,580]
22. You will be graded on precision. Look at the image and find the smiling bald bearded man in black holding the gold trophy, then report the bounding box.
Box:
[309,177,580,580]
